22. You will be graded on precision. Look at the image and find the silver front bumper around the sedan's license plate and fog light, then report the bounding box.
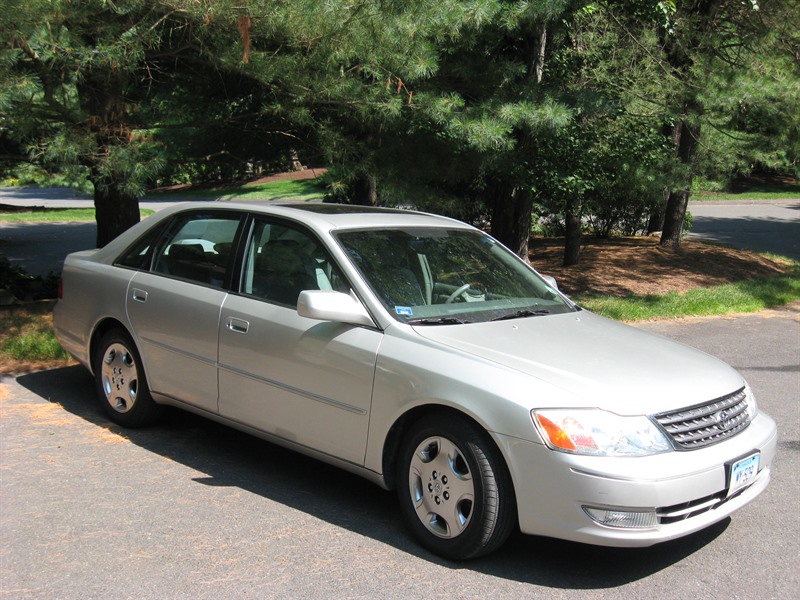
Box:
[494,413,777,547]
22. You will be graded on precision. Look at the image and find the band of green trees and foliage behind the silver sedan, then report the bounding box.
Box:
[0,0,800,263]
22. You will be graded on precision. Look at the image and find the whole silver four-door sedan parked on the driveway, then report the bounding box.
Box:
[55,203,777,559]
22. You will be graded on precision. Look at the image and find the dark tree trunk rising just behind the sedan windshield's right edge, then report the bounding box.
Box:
[491,184,533,262]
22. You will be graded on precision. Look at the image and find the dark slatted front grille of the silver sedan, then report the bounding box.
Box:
[655,388,751,450]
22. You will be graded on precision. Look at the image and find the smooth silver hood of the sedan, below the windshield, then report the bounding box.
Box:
[414,311,744,414]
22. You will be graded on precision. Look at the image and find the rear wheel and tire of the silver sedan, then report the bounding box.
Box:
[92,329,162,427]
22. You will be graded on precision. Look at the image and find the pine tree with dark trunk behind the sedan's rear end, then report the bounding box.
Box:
[0,0,276,246]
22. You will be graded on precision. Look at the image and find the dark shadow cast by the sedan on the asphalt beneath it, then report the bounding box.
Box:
[17,366,730,589]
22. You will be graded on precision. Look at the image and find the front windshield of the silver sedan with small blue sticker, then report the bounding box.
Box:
[336,228,575,325]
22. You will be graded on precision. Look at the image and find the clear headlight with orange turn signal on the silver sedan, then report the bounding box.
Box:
[531,409,672,456]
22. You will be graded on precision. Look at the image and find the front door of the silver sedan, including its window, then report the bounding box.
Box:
[219,219,382,464]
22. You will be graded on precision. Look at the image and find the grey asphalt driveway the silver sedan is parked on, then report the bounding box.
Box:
[0,306,800,600]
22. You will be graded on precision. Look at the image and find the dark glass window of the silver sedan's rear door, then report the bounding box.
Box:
[153,214,241,287]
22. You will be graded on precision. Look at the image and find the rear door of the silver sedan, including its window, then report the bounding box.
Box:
[127,211,242,413]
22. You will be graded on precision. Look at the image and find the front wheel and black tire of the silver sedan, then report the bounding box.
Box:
[397,415,516,560]
